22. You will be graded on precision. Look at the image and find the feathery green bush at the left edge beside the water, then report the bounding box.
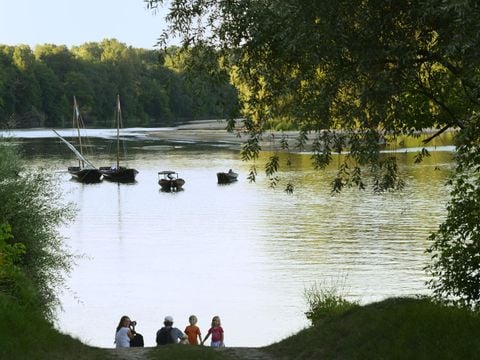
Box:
[0,139,73,319]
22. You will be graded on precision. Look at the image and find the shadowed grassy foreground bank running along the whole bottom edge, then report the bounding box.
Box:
[0,295,480,360]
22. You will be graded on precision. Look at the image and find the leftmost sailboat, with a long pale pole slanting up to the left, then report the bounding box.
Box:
[53,96,102,183]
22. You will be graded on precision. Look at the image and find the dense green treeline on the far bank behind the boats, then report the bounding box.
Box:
[0,39,236,128]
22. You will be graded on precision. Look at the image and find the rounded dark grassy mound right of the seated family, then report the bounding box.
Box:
[267,298,480,360]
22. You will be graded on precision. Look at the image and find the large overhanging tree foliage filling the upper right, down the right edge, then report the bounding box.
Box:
[145,0,480,305]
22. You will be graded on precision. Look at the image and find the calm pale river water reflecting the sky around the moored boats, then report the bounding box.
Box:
[4,130,452,347]
